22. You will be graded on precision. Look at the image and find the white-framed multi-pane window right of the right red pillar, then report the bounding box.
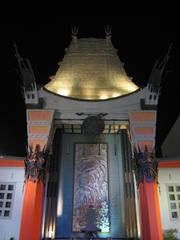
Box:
[167,184,180,220]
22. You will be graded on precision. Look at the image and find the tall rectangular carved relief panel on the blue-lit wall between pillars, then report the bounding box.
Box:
[73,144,110,232]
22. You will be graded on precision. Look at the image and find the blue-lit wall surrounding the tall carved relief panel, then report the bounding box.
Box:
[56,134,125,237]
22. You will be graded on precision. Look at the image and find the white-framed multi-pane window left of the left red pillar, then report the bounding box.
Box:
[0,182,15,218]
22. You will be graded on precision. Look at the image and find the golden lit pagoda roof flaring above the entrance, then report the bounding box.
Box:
[45,37,138,100]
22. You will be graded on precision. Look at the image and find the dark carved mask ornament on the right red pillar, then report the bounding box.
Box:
[134,145,158,185]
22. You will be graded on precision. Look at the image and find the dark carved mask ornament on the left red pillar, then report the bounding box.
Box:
[25,144,49,182]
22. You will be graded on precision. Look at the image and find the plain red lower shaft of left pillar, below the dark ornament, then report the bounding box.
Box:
[20,180,44,240]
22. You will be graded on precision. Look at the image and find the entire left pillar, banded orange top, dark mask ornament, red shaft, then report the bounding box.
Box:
[20,109,54,240]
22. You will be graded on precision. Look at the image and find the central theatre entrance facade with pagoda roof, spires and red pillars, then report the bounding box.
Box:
[0,29,174,240]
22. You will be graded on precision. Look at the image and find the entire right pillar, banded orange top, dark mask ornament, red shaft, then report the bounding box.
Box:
[129,111,163,240]
